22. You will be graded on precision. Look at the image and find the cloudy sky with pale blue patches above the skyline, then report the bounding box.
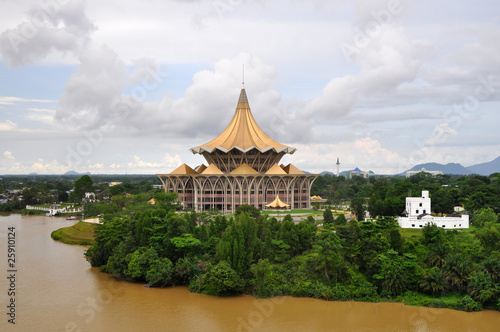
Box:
[0,0,500,174]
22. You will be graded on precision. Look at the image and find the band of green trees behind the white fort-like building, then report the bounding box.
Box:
[311,173,500,221]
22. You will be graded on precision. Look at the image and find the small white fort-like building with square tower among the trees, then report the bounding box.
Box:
[398,190,469,229]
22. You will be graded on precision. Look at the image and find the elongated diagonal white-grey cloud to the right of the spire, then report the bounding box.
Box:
[301,24,429,126]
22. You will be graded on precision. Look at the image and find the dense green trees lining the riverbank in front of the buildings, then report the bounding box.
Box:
[87,200,500,311]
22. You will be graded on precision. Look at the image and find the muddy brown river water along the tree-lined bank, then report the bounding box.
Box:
[0,214,500,332]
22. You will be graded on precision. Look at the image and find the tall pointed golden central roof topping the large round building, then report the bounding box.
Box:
[190,88,295,154]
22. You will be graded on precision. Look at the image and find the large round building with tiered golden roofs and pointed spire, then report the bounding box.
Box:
[157,88,317,213]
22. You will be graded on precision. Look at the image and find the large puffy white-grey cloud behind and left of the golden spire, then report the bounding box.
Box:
[56,50,281,141]
